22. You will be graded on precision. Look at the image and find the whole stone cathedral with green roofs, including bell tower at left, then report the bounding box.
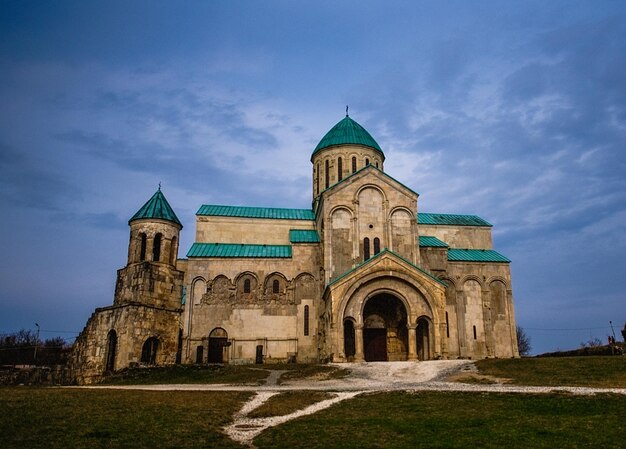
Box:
[72,115,518,383]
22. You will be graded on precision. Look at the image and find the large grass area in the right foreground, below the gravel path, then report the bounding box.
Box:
[254,392,626,449]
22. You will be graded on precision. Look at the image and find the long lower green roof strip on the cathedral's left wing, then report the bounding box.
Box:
[187,243,291,259]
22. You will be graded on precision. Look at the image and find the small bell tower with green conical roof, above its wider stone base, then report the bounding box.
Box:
[114,186,183,309]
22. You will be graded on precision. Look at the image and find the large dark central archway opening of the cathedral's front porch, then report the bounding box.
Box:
[363,293,409,362]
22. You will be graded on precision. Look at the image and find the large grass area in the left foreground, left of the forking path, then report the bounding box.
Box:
[0,387,250,449]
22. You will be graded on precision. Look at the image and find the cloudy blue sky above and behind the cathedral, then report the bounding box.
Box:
[0,0,626,353]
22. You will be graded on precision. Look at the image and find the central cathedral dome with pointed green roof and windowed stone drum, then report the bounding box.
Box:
[311,112,385,201]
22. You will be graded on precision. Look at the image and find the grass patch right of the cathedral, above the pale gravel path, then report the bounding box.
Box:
[476,356,626,388]
